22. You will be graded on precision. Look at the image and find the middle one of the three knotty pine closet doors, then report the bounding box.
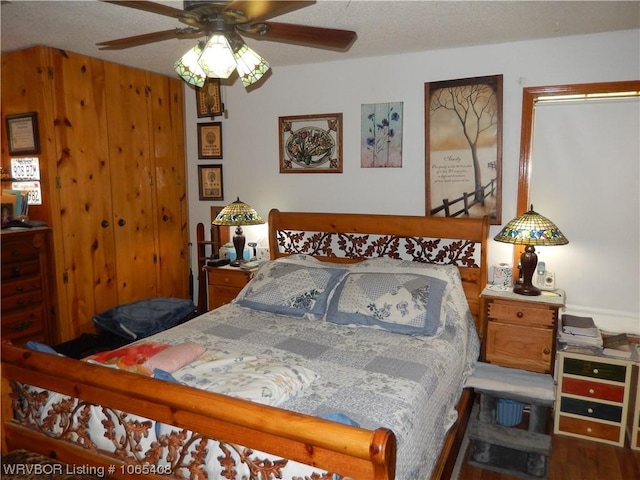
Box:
[102,63,157,304]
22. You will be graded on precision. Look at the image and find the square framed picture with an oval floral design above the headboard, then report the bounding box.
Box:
[278,113,342,173]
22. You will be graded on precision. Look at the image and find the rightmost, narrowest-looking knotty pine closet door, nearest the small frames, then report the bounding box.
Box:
[149,74,189,298]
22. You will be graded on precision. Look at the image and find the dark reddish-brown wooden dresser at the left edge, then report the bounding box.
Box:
[1,228,55,344]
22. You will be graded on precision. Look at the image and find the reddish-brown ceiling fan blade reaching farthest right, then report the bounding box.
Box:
[238,22,358,50]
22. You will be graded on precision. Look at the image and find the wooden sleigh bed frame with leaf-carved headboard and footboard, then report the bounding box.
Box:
[1,210,489,480]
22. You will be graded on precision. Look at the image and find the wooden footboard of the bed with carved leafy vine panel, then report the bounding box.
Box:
[2,344,396,480]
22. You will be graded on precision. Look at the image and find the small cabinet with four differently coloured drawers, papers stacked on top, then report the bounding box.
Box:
[554,351,637,446]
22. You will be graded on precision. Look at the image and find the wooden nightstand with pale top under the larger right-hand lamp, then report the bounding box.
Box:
[480,288,564,373]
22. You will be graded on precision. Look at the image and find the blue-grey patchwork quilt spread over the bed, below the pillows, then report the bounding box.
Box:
[153,296,479,480]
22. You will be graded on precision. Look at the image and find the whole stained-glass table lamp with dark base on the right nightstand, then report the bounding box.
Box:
[494,205,569,296]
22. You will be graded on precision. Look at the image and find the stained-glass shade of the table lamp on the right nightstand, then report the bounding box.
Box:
[494,205,569,245]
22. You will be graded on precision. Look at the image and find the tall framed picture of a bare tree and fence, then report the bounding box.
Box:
[424,75,502,225]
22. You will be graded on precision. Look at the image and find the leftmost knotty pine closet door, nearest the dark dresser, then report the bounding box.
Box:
[52,49,118,339]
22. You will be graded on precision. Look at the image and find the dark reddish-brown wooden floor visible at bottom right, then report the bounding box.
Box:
[458,435,640,480]
